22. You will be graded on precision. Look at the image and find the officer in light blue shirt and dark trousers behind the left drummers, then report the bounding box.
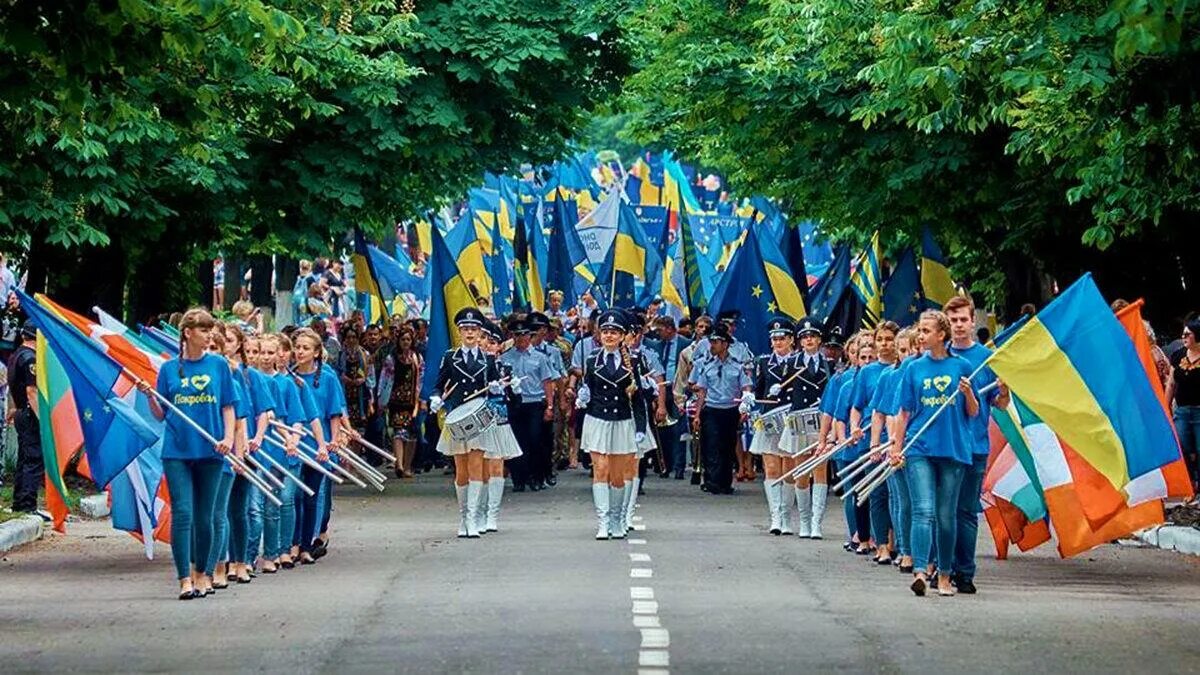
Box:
[500,321,554,492]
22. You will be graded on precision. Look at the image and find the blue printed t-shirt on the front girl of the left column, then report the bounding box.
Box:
[155,353,235,460]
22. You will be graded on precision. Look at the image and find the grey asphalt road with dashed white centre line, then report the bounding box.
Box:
[0,472,1200,674]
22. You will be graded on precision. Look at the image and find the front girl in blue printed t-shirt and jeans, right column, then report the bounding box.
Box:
[889,311,979,596]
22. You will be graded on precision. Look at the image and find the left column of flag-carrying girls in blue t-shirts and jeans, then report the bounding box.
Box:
[138,309,365,601]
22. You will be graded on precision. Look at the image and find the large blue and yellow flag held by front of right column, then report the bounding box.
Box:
[986,274,1180,490]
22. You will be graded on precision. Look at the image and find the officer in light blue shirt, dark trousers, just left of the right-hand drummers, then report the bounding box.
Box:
[692,324,754,495]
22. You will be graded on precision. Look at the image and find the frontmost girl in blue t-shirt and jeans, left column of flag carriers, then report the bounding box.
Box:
[139,309,235,599]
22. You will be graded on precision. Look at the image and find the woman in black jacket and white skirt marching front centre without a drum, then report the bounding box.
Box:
[575,310,647,539]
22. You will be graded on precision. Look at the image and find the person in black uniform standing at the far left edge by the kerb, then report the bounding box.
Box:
[7,321,41,513]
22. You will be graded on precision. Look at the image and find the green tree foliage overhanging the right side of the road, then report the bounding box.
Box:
[624,0,1200,314]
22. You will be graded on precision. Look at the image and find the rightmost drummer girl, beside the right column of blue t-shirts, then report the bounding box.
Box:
[780,317,841,539]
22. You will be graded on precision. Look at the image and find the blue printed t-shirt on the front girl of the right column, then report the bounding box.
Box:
[899,354,972,464]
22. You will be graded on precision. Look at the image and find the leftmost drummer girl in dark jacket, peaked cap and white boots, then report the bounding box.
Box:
[430,307,503,539]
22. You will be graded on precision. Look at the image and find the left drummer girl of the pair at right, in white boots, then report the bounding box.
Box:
[750,318,796,536]
